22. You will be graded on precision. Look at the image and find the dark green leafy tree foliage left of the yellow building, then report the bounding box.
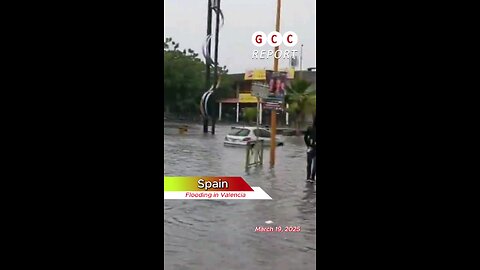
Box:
[163,38,233,115]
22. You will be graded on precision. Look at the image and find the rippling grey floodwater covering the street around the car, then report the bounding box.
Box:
[163,125,316,270]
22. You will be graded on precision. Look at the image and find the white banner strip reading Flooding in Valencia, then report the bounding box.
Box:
[164,187,272,200]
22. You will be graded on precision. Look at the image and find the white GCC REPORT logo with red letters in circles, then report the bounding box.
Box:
[252,31,298,59]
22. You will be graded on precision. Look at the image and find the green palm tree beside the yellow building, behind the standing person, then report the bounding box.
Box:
[285,80,317,136]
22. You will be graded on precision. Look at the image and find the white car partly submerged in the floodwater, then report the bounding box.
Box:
[223,127,283,146]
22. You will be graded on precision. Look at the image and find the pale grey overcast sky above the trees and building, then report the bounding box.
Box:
[164,0,316,73]
